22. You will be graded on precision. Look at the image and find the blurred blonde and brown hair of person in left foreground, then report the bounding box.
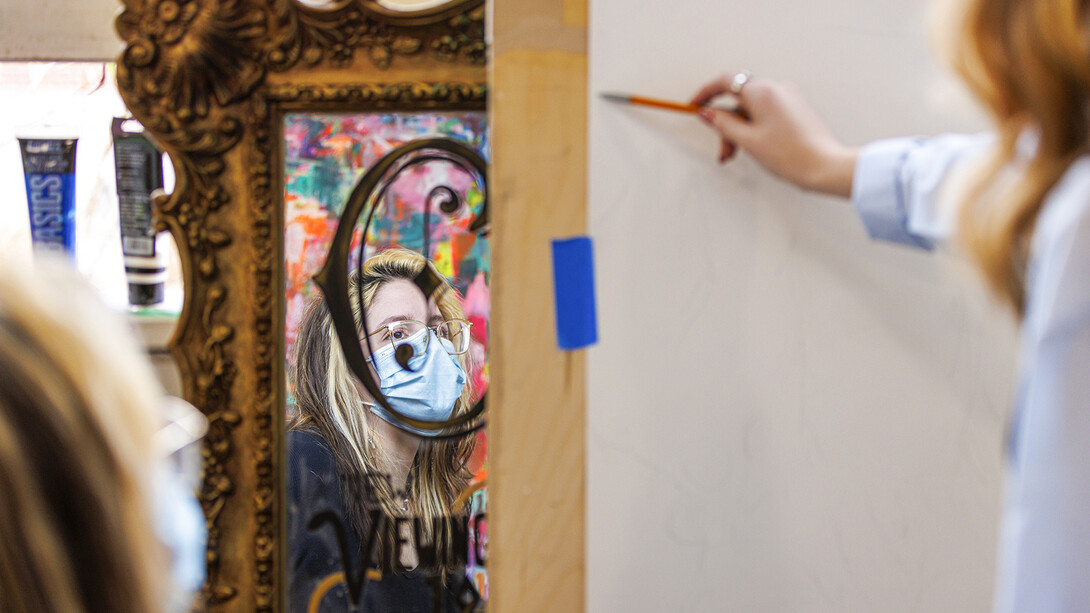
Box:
[0,254,168,613]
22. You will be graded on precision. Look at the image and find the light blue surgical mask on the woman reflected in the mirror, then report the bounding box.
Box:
[367,328,465,436]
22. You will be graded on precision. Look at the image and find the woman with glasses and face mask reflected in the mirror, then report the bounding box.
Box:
[287,249,474,611]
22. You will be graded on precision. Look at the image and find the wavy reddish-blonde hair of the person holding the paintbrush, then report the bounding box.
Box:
[948,0,1090,316]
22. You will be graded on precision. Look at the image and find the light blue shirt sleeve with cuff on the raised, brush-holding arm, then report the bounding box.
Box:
[851,134,995,250]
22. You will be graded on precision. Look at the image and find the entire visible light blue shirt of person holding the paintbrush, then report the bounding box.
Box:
[852,136,1090,613]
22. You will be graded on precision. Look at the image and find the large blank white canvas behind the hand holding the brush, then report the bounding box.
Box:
[586,0,1015,613]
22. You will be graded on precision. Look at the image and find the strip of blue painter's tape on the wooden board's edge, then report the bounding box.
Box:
[553,237,598,349]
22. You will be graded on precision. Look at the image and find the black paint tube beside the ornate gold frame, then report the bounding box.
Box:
[110,117,167,307]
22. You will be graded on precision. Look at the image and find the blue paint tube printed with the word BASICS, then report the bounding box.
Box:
[19,139,76,255]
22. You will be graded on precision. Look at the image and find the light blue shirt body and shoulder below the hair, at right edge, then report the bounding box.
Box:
[996,158,1090,613]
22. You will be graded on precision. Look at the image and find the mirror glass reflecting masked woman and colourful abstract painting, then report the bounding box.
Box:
[283,112,491,611]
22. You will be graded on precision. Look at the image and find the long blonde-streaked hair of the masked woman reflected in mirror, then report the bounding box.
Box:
[288,249,474,570]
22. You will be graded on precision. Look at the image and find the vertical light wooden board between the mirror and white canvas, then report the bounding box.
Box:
[488,0,586,613]
